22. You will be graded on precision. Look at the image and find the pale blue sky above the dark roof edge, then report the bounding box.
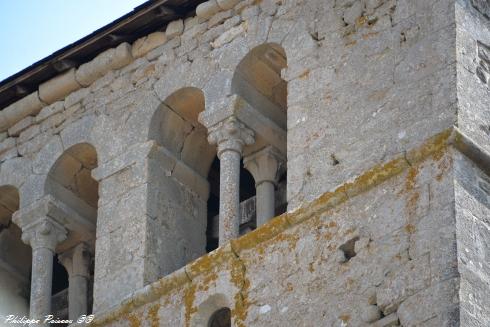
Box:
[0,0,145,81]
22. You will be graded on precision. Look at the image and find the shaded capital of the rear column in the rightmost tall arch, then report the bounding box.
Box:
[243,146,286,186]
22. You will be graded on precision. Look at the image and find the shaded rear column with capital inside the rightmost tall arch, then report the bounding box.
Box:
[243,146,285,227]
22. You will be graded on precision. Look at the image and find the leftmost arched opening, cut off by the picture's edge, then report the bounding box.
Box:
[0,186,31,320]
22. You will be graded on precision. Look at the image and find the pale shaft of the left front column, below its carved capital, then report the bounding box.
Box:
[30,248,54,326]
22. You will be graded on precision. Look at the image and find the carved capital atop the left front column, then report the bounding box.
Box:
[22,217,67,252]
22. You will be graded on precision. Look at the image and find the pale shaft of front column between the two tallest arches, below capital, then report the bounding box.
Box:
[219,150,241,245]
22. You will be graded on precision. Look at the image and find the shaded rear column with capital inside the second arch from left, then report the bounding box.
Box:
[59,243,91,321]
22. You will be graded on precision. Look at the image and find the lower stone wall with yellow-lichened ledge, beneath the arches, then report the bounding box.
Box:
[90,133,459,326]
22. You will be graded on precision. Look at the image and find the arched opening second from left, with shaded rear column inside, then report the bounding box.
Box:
[45,143,99,319]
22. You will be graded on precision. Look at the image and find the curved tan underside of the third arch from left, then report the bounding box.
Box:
[148,87,216,177]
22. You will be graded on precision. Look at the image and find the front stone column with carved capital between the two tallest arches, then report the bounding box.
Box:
[208,116,255,245]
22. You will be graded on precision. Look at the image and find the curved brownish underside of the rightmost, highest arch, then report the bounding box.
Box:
[231,43,287,129]
